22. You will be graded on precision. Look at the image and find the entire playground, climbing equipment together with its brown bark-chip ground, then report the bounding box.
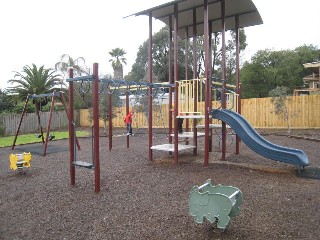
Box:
[0,1,320,240]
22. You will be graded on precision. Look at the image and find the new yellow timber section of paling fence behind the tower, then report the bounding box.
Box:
[80,95,320,129]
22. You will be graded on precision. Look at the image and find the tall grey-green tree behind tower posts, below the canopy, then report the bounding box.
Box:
[126,26,246,82]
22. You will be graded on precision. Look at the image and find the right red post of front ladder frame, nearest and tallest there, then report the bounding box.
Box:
[93,63,100,193]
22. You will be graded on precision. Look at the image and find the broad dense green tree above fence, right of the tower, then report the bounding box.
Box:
[241,45,320,98]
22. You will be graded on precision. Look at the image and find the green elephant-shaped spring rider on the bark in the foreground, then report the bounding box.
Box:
[188,179,243,230]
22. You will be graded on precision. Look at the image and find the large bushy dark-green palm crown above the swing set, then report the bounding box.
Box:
[7,64,61,100]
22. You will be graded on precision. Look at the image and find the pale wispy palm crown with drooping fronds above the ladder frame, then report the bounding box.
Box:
[55,54,87,77]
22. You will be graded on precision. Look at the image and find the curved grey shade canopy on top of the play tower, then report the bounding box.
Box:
[130,0,263,38]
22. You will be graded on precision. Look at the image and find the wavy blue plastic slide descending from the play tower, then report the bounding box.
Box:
[212,109,309,169]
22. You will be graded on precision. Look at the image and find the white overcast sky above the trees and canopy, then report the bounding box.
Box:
[0,0,320,89]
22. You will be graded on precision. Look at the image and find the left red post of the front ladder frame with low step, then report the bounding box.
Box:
[69,68,76,185]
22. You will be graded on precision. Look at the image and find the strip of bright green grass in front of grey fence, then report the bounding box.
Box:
[0,131,90,147]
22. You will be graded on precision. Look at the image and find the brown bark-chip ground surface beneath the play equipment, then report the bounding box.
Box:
[0,129,320,239]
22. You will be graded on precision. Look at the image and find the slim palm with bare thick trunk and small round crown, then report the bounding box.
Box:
[109,48,127,80]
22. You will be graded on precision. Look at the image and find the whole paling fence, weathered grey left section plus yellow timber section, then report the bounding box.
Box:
[0,95,320,135]
